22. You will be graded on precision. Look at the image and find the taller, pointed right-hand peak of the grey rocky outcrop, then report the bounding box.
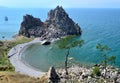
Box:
[46,6,81,35]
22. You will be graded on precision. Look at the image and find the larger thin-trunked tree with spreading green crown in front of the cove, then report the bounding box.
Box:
[59,36,84,75]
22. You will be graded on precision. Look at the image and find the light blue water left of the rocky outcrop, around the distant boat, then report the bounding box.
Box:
[0,8,49,40]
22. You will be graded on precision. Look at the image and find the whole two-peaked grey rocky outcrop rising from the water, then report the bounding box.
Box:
[19,6,81,39]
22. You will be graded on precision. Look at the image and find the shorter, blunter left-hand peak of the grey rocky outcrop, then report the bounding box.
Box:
[19,15,44,37]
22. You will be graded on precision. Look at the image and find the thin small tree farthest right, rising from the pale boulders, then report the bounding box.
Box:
[96,43,116,78]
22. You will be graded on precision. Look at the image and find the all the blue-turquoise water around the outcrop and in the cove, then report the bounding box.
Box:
[0,9,120,71]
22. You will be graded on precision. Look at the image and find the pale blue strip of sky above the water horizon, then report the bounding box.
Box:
[0,0,120,8]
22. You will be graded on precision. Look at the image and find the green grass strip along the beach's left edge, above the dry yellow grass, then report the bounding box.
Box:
[0,36,33,71]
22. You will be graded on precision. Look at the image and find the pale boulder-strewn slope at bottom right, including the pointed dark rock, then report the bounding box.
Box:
[40,65,120,83]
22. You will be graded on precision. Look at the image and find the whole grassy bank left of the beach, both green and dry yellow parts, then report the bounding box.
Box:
[0,36,47,83]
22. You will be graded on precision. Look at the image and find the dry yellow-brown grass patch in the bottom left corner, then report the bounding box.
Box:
[0,72,42,83]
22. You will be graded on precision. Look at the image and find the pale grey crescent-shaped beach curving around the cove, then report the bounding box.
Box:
[8,38,45,77]
